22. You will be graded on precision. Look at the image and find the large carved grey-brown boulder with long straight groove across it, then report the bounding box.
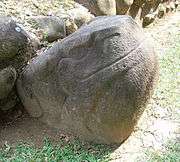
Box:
[17,16,158,144]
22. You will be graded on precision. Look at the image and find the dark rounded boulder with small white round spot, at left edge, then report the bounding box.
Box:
[0,16,28,69]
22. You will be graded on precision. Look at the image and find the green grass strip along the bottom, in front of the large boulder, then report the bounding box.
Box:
[0,139,113,162]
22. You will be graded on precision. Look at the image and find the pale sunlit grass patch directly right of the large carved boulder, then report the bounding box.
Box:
[155,35,180,110]
